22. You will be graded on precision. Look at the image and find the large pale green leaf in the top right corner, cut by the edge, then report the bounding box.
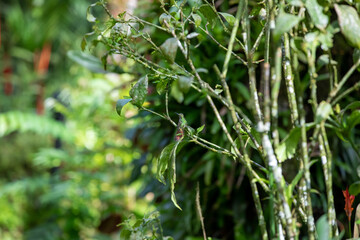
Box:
[335,4,360,48]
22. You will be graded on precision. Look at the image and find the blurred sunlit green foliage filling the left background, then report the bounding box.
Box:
[0,0,154,240]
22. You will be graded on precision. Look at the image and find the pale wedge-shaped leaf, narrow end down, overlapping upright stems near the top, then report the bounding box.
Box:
[273,10,302,41]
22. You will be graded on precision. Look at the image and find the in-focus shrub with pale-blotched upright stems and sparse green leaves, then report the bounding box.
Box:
[86,0,360,239]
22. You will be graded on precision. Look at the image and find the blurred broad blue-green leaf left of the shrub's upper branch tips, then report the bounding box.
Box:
[67,51,106,73]
